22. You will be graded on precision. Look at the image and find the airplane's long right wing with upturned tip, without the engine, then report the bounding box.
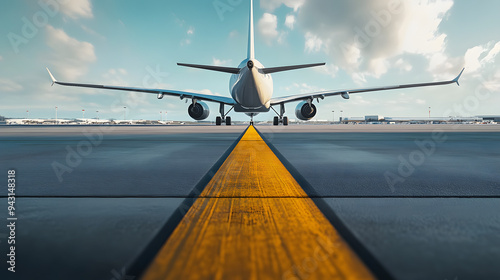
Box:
[271,68,465,105]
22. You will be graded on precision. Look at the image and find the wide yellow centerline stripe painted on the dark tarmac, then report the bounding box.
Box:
[142,126,374,280]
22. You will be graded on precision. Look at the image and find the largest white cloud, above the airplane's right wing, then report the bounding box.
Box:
[296,0,460,83]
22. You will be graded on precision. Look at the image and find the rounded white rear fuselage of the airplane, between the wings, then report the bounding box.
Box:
[229,59,273,113]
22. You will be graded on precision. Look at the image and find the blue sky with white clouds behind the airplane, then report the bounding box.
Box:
[0,0,500,121]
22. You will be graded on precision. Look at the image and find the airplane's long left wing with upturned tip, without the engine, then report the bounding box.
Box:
[46,68,236,105]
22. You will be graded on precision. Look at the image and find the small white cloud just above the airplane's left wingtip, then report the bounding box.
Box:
[46,25,96,80]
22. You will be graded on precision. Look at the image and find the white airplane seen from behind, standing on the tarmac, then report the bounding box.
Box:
[46,0,465,126]
